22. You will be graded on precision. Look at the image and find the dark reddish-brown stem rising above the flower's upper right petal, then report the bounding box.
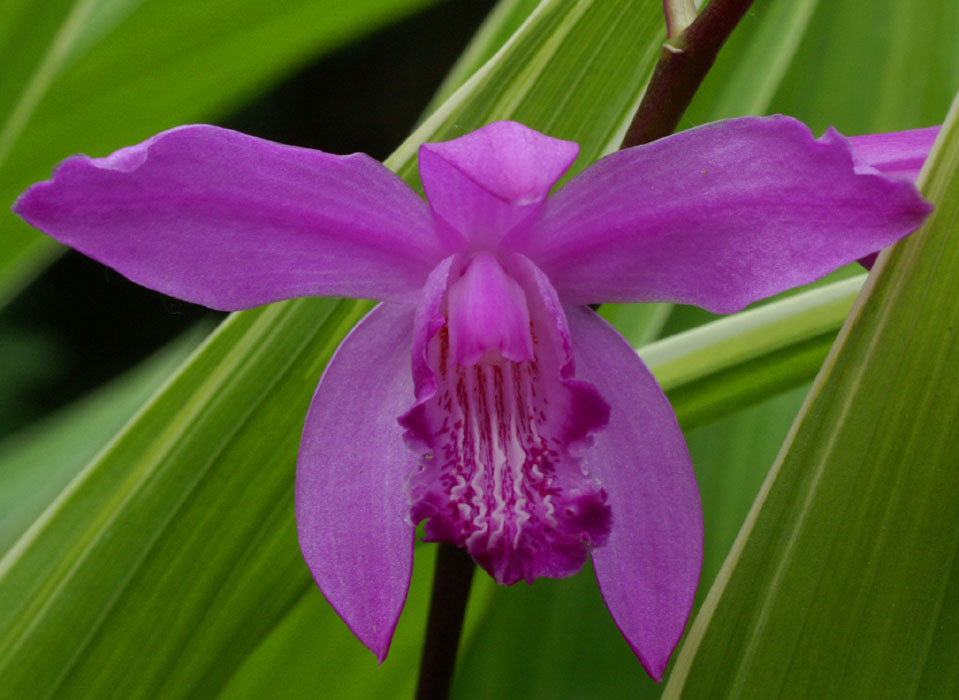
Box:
[620,0,753,148]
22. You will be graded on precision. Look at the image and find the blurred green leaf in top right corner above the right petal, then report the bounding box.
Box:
[771,0,959,134]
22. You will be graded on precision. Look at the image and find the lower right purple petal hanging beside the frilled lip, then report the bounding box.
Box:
[566,307,703,680]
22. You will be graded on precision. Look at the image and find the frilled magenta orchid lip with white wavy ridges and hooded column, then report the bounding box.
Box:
[401,253,611,584]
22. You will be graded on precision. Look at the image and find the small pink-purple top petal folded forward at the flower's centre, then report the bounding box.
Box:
[419,121,579,252]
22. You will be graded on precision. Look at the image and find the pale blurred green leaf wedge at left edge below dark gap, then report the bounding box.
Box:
[0,329,203,553]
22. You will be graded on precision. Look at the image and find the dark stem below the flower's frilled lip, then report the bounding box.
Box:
[416,542,476,700]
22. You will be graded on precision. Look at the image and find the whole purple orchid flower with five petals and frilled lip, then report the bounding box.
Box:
[15,117,930,680]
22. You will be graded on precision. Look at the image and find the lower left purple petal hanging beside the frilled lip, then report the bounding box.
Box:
[296,303,416,661]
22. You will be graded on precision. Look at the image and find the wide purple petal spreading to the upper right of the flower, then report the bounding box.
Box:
[520,117,931,313]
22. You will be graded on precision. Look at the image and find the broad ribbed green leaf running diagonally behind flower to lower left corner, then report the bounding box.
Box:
[0,0,662,700]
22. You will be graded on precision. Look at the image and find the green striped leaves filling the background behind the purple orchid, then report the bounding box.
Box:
[0,0,959,700]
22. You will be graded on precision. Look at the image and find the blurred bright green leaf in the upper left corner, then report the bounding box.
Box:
[0,0,435,302]
